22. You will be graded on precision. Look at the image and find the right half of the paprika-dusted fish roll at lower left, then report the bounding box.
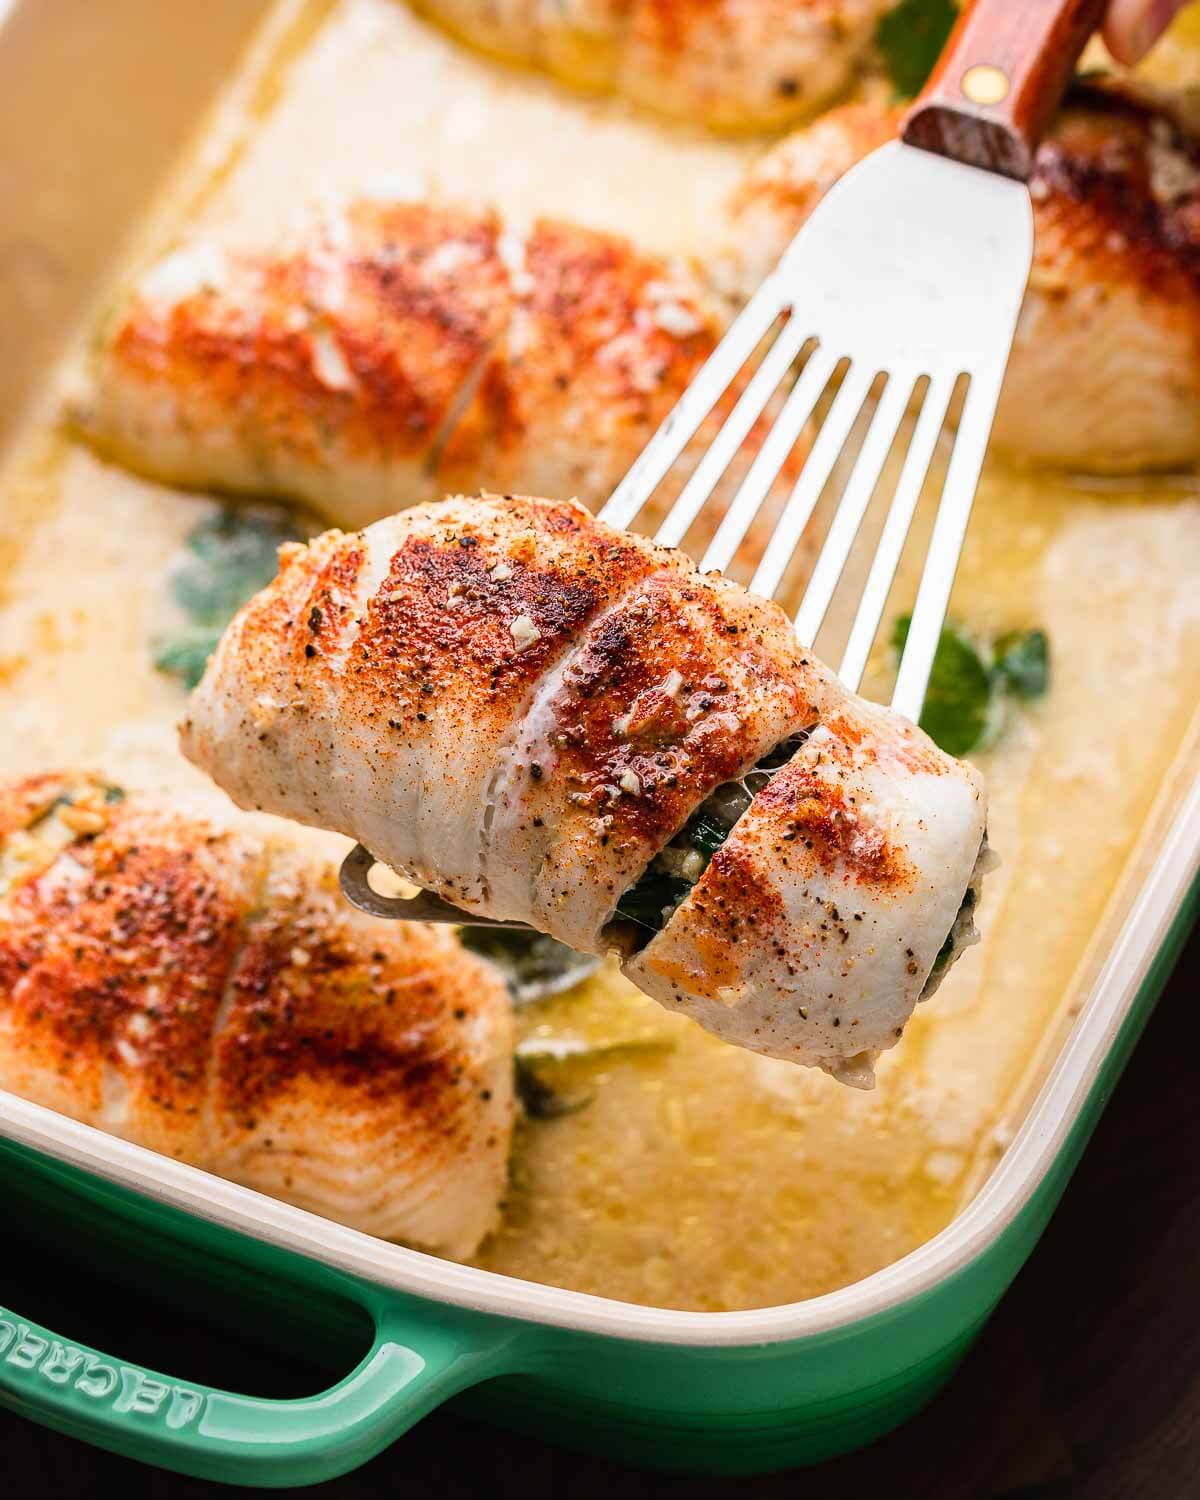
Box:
[212,848,515,1260]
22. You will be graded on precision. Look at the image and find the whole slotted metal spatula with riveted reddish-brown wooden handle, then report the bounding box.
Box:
[342,0,1104,927]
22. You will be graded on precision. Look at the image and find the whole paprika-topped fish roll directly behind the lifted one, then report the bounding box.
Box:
[71,201,722,527]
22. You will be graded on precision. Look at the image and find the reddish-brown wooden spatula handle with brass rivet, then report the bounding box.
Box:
[900,0,1106,180]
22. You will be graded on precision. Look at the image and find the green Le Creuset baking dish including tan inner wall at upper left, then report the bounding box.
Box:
[0,0,1200,1485]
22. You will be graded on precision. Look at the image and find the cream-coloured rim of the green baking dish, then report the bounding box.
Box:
[0,756,1200,1349]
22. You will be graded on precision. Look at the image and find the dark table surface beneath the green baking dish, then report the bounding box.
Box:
[0,933,1200,1500]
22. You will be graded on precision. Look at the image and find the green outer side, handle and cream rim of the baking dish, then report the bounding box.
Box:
[0,782,1200,1485]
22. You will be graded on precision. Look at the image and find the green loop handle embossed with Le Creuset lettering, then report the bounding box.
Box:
[0,1301,515,1487]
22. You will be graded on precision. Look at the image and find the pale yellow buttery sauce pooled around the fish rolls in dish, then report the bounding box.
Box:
[0,0,1200,1310]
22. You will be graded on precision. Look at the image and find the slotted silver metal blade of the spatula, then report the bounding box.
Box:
[342,143,1034,926]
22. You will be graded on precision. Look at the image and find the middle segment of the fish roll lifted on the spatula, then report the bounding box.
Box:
[486,569,825,951]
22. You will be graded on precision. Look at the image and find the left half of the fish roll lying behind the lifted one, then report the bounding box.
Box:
[74,203,510,525]
